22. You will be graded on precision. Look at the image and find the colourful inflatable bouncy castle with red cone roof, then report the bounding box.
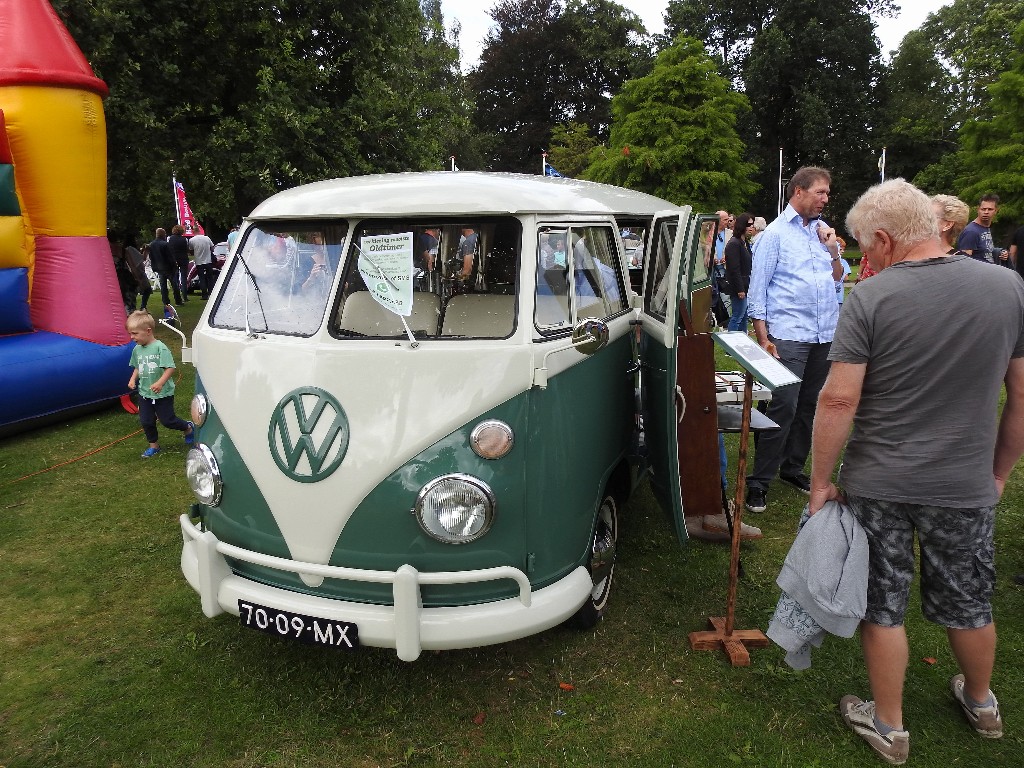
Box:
[0,0,131,434]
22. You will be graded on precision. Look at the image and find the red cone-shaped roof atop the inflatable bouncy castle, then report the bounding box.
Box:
[0,0,110,96]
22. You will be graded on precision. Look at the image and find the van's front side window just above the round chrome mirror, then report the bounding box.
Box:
[535,226,627,332]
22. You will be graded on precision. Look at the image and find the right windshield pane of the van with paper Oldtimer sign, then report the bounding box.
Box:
[330,217,521,339]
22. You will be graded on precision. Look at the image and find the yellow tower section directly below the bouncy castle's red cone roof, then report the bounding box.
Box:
[0,85,106,237]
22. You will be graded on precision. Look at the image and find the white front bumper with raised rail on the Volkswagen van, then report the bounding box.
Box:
[180,515,593,662]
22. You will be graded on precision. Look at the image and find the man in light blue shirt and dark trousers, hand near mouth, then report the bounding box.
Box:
[746,166,843,512]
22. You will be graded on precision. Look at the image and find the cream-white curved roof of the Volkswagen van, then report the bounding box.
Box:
[249,171,680,219]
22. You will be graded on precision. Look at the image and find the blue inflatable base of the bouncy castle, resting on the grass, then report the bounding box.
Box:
[0,331,132,431]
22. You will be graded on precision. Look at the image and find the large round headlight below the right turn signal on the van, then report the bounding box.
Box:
[413,474,496,544]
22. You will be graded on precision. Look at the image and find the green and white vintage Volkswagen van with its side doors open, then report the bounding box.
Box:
[180,172,714,660]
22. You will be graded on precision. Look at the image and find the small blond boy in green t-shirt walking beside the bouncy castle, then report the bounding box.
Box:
[125,309,196,459]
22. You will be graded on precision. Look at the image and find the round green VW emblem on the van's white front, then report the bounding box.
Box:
[269,387,349,482]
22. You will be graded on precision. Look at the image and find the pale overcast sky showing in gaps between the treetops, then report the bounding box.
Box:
[441,0,952,70]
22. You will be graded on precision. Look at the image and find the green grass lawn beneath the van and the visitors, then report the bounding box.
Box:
[0,299,1024,768]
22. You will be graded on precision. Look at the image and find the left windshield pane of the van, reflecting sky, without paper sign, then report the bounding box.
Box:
[210,222,347,336]
